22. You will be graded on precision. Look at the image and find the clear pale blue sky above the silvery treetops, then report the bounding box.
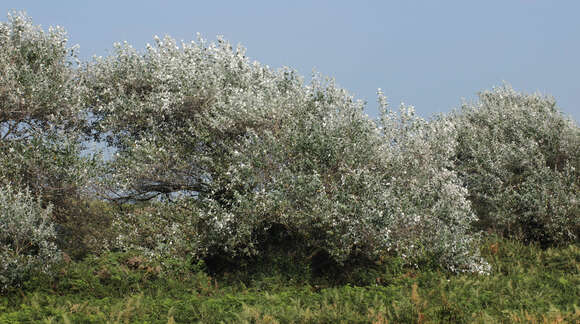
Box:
[0,0,580,121]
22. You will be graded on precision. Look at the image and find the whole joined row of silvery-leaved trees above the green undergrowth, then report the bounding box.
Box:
[7,10,580,272]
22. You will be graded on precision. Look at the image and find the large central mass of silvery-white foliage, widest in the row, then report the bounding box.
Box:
[85,37,487,272]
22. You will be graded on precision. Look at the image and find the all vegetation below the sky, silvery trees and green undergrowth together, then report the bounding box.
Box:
[0,12,580,323]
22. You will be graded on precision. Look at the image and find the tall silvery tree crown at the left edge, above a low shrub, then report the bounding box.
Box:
[0,12,91,201]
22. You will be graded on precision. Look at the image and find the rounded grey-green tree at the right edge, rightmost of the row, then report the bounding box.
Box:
[450,85,580,244]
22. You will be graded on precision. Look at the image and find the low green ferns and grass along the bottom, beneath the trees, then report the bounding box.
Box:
[0,238,580,323]
